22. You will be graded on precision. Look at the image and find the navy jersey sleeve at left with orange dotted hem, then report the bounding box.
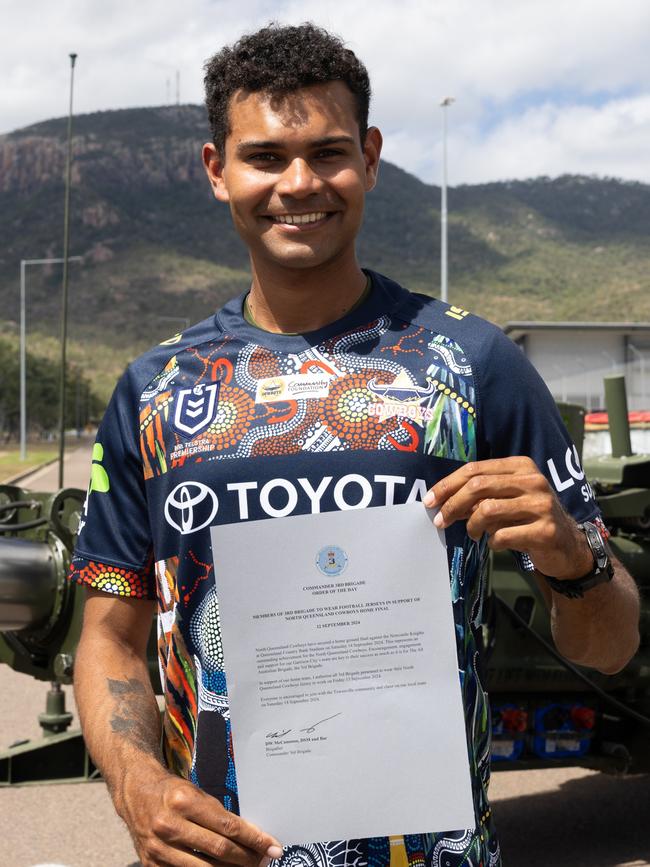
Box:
[69,370,156,599]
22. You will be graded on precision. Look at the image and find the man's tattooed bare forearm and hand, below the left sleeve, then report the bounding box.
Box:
[74,590,282,867]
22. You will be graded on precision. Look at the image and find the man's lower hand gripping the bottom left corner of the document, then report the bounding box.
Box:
[119,763,282,867]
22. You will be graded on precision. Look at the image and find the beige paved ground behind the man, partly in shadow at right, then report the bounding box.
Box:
[0,444,650,867]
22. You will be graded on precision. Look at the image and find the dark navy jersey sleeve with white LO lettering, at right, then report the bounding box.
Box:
[470,330,604,569]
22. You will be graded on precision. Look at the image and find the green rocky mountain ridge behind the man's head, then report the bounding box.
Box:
[0,105,650,400]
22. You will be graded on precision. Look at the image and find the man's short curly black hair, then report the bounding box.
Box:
[203,22,370,153]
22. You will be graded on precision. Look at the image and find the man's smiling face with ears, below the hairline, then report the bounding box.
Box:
[203,81,381,270]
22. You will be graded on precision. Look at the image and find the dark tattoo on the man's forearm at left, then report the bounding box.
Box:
[106,677,160,758]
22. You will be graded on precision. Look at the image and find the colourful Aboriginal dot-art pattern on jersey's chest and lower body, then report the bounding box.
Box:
[134,317,500,867]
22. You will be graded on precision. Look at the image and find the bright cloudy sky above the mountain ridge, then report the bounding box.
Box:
[0,0,650,186]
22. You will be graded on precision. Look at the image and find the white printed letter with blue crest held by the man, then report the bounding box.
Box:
[211,503,475,845]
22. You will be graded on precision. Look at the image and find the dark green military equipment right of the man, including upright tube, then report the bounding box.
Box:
[485,379,650,771]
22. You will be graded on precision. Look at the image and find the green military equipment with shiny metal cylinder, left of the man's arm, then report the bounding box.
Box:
[0,485,160,787]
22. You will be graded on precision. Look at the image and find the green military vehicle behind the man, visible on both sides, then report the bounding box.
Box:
[0,377,650,786]
